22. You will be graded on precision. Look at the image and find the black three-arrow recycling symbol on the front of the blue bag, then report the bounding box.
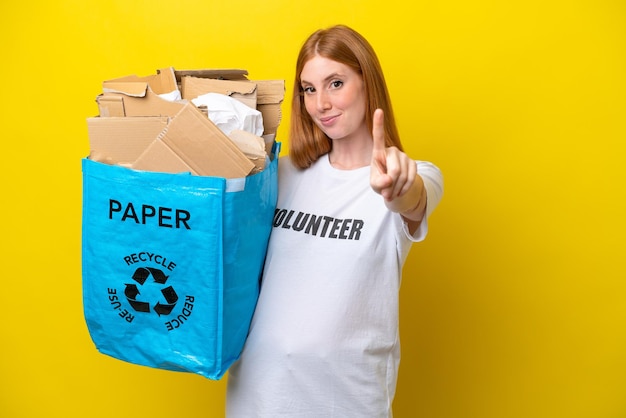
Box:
[124,267,178,316]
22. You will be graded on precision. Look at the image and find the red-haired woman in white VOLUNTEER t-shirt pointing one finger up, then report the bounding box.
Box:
[226,26,443,418]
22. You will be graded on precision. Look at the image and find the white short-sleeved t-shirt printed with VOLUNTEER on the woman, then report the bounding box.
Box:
[226,156,442,418]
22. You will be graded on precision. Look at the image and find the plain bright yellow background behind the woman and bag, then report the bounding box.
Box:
[0,0,626,418]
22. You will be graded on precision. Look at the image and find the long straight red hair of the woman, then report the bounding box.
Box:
[289,25,402,169]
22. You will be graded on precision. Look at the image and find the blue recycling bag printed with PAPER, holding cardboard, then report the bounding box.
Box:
[82,143,280,380]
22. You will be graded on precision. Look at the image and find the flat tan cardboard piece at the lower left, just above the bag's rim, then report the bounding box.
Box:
[87,116,169,165]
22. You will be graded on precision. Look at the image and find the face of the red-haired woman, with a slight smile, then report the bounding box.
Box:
[300,55,371,140]
